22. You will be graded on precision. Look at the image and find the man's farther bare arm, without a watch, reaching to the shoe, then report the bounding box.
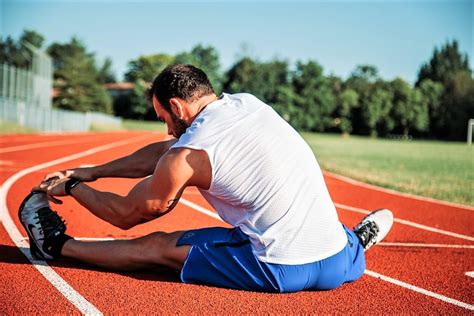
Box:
[43,139,176,182]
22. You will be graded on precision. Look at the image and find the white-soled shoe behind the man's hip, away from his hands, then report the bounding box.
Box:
[353,209,393,251]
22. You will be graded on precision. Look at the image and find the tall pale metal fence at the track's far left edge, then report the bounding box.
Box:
[0,45,122,132]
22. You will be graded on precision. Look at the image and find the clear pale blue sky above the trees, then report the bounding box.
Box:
[0,0,474,83]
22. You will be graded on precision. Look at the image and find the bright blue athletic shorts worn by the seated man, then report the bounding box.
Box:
[176,226,365,293]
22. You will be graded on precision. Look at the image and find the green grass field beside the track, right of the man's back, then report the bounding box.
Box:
[303,133,474,205]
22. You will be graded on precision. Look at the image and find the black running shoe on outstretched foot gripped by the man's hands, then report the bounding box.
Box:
[18,191,71,260]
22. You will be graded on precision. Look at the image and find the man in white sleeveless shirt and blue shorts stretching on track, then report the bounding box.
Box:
[19,65,393,292]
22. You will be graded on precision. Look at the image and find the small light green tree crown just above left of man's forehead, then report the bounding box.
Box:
[125,54,175,82]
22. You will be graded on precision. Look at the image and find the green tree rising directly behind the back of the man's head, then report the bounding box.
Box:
[175,44,222,94]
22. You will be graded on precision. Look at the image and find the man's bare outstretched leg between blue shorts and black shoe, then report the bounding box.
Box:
[61,231,191,271]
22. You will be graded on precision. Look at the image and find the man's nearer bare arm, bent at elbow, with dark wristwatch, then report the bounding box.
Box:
[40,149,211,229]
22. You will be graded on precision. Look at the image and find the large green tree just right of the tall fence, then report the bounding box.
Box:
[48,37,112,113]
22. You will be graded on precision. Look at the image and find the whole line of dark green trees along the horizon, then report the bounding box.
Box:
[0,31,474,140]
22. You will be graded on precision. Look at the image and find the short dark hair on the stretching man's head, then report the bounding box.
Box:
[148,64,214,112]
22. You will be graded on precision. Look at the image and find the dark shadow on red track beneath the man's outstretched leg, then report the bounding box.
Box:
[0,245,181,283]
